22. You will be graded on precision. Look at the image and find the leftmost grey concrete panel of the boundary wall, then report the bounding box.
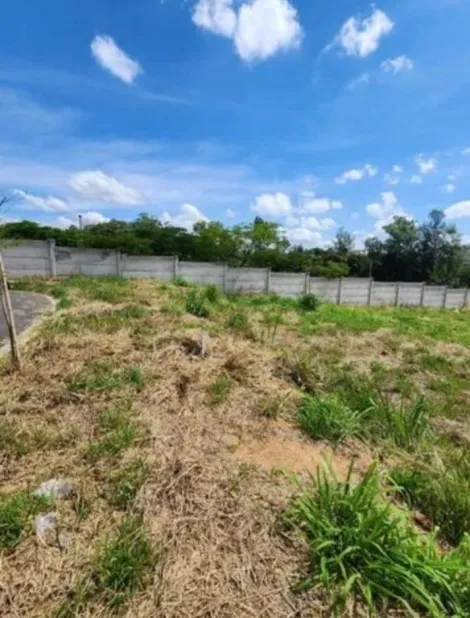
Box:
[3,240,53,277]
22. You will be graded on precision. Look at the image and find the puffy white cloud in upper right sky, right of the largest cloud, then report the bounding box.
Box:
[326,9,394,58]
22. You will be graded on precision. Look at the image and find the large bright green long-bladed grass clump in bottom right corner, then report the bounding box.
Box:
[286,467,470,618]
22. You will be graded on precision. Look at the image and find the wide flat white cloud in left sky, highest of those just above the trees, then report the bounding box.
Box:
[69,170,144,206]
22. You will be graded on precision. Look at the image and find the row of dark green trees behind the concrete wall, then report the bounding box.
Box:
[0,210,470,286]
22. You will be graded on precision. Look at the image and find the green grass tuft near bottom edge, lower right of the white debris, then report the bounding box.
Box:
[92,515,157,609]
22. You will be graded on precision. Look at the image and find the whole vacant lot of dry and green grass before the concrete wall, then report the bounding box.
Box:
[0,277,470,618]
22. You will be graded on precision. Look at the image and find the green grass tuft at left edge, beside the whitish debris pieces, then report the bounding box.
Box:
[0,493,50,551]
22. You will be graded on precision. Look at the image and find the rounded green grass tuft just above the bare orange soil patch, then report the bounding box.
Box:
[297,395,364,446]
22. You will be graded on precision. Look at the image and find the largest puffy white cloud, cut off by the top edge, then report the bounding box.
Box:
[192,0,302,62]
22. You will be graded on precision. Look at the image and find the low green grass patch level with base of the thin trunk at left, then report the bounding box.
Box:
[68,360,145,393]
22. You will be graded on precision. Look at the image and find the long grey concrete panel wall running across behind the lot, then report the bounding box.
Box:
[3,241,470,309]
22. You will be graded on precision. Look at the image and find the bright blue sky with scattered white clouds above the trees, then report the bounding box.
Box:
[0,0,470,246]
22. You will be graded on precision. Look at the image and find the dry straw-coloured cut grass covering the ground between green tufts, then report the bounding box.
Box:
[0,281,468,618]
